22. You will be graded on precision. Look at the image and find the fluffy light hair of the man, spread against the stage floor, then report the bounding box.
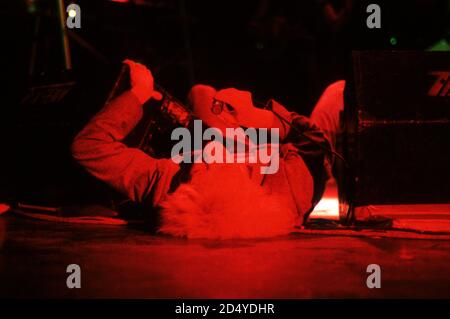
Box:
[159,164,298,239]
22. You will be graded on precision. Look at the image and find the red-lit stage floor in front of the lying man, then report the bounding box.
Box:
[0,214,450,298]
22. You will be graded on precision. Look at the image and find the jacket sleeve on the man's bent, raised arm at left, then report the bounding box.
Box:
[71,91,179,206]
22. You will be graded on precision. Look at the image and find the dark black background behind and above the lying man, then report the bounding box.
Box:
[0,0,450,208]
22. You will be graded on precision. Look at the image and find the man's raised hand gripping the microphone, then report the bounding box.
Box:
[123,59,162,104]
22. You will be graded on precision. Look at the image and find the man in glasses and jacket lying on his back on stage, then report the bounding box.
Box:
[72,60,344,238]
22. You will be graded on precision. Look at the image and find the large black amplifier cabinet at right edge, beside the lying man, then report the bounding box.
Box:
[338,51,450,222]
